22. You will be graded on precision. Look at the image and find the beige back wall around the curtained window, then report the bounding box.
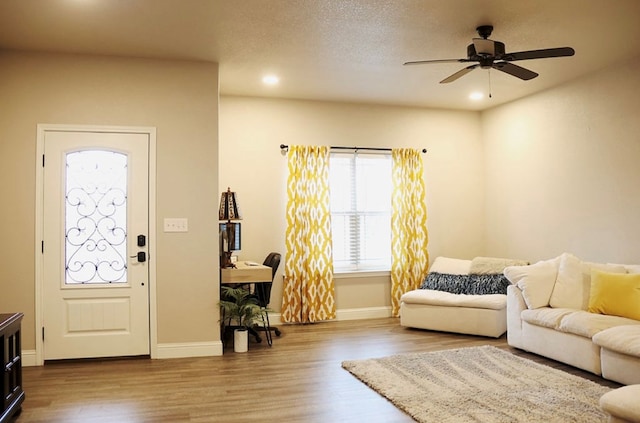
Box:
[219,96,484,310]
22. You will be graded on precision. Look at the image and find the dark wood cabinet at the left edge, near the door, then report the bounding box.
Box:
[0,313,24,423]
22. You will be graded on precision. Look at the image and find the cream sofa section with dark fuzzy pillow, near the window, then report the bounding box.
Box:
[400,257,526,338]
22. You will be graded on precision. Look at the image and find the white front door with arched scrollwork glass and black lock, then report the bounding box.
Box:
[42,130,150,360]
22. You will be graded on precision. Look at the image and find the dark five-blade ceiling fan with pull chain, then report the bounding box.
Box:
[404,25,575,84]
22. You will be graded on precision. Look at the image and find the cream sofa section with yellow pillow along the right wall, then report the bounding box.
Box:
[504,253,640,385]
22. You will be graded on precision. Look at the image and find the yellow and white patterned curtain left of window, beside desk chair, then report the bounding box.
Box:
[282,146,336,323]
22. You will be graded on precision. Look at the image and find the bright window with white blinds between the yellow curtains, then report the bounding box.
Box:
[329,153,392,272]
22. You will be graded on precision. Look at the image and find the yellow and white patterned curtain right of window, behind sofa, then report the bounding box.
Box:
[391,148,429,316]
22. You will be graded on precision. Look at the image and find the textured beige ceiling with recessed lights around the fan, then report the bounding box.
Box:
[0,0,640,110]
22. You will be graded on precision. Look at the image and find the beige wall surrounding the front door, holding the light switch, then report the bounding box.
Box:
[0,52,219,349]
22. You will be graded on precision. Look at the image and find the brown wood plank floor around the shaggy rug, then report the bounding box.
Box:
[16,318,619,423]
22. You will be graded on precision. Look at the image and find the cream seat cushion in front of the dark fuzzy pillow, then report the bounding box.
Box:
[400,289,507,310]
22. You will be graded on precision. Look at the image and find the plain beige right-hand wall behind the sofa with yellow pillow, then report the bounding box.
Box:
[482,55,640,263]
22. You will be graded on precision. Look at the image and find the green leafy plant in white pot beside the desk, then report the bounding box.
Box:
[219,286,264,352]
